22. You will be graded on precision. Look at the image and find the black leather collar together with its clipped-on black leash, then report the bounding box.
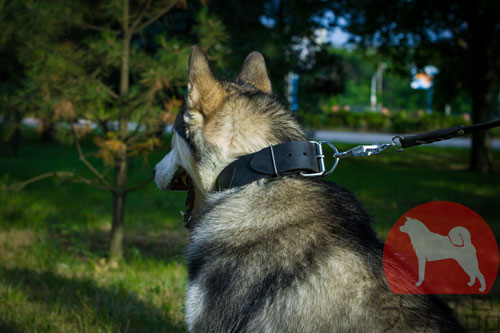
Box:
[216,120,500,191]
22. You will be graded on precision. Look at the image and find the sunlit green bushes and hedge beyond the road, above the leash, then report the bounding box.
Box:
[299,49,478,133]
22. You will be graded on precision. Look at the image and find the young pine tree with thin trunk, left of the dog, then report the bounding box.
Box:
[4,0,226,259]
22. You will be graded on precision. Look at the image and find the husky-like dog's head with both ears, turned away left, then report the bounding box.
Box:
[155,46,305,220]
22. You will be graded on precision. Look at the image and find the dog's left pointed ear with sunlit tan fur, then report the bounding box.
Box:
[188,45,225,116]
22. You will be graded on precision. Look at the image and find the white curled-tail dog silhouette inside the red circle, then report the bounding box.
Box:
[399,217,486,292]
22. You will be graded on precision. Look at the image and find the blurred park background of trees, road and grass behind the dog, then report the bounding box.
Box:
[0,0,500,332]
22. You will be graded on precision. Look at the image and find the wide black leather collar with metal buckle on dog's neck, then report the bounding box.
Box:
[215,141,324,191]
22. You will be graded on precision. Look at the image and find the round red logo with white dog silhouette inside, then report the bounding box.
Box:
[384,201,499,294]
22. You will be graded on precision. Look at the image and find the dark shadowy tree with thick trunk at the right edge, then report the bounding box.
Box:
[332,0,500,172]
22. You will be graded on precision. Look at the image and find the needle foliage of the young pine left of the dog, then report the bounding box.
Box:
[0,0,228,162]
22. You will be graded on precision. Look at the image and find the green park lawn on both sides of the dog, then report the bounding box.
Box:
[0,128,500,332]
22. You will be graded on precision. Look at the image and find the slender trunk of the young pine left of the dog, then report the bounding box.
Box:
[109,0,132,260]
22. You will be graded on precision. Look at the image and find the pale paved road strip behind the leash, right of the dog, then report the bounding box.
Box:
[312,131,500,150]
